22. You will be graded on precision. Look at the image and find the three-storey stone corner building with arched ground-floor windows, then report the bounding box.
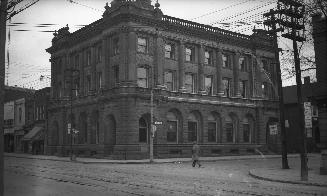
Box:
[46,0,279,159]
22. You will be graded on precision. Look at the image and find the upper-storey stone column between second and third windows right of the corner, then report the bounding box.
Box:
[178,41,186,92]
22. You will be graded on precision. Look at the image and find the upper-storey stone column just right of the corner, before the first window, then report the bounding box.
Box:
[126,31,137,86]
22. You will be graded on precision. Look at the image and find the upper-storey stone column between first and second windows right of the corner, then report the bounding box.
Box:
[154,35,165,88]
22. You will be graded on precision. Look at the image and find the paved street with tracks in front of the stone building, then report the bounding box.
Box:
[5,157,327,196]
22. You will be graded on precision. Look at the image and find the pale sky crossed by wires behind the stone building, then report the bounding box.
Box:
[5,0,292,89]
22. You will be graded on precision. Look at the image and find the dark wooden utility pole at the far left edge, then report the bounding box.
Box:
[0,0,8,196]
